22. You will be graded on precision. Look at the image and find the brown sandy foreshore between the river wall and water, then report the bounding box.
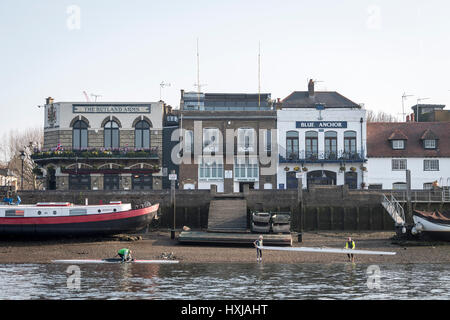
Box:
[0,231,450,264]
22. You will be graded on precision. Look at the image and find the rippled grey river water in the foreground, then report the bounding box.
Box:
[0,263,450,300]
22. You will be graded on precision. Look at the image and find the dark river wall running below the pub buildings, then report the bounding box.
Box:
[15,186,448,231]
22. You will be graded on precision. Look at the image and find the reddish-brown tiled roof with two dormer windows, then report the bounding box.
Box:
[367,122,450,157]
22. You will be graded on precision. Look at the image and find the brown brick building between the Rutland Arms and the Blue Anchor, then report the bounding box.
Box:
[179,90,277,193]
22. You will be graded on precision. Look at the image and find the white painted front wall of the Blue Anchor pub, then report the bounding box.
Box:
[277,108,367,189]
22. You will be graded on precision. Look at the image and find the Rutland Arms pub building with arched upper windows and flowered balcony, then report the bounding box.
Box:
[32,98,163,190]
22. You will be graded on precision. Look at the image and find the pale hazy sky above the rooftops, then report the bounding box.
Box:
[0,0,450,137]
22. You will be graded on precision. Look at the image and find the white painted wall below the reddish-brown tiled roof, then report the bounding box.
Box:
[367,157,450,190]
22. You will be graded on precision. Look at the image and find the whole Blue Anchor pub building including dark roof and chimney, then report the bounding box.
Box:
[277,80,367,189]
